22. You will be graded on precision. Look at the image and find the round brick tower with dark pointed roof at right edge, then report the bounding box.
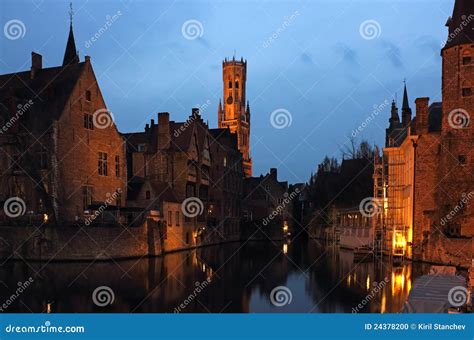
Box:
[437,0,474,236]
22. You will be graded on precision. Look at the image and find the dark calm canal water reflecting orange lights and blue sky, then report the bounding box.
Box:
[0,240,436,313]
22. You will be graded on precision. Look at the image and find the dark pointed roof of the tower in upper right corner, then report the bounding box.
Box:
[445,0,474,48]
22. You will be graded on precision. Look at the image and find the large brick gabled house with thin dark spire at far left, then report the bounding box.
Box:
[0,24,127,224]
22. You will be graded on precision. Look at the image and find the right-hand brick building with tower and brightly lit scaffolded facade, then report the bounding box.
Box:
[383,0,474,266]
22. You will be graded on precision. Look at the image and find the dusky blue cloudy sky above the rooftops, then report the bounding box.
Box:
[0,0,454,182]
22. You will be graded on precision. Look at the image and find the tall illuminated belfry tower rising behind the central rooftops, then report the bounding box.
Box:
[218,57,252,177]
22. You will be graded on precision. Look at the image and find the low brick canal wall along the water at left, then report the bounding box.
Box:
[0,220,239,261]
